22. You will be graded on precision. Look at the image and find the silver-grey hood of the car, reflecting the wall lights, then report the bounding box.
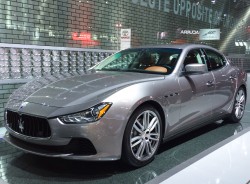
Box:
[10,71,164,107]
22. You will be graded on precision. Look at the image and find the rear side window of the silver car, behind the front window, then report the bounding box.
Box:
[204,49,226,71]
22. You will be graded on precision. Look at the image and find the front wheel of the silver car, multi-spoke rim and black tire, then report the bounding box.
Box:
[122,105,162,167]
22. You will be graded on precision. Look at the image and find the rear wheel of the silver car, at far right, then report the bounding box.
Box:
[226,87,246,123]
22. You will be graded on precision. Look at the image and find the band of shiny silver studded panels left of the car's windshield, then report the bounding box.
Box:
[0,44,115,83]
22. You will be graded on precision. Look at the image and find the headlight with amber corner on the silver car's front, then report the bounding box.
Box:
[59,103,112,124]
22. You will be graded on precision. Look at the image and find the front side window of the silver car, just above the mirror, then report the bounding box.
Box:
[184,49,205,66]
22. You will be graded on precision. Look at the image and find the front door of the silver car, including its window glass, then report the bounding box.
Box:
[174,49,215,130]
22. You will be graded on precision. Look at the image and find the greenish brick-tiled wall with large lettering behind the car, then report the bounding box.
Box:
[0,0,250,54]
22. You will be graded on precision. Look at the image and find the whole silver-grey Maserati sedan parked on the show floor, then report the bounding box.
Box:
[4,44,247,167]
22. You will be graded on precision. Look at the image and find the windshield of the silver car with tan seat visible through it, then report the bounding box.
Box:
[94,48,181,74]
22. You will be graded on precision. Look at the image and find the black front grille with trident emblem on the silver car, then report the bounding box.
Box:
[6,110,51,138]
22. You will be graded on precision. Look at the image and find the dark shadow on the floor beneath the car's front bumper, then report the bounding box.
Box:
[6,153,133,180]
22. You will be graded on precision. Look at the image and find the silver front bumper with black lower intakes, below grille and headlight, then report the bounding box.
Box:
[4,115,125,161]
